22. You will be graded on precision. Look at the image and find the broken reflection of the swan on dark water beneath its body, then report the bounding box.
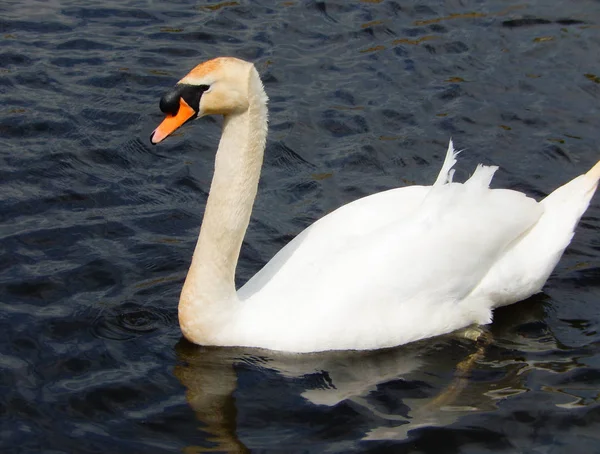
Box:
[175,301,564,452]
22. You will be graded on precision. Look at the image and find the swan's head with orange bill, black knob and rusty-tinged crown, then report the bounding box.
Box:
[150,57,254,144]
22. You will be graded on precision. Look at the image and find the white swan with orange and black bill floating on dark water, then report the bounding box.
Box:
[150,57,600,353]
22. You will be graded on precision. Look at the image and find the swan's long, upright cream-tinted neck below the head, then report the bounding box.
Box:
[179,68,267,343]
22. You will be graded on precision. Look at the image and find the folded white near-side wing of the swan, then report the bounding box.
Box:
[276,167,543,310]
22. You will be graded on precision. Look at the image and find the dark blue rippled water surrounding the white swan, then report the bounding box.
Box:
[0,0,600,454]
